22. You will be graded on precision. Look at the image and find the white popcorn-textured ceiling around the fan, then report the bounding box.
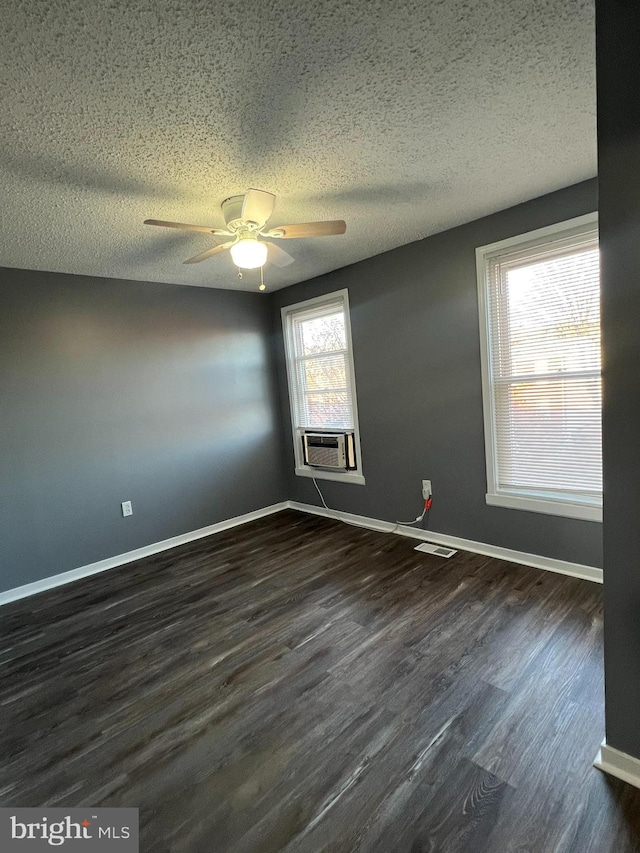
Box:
[0,0,596,289]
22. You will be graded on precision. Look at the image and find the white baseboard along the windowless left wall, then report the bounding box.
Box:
[0,501,289,606]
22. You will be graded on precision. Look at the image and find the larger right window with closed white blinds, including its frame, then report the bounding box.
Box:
[476,214,602,521]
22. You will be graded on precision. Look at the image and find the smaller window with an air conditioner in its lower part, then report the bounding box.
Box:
[282,290,364,484]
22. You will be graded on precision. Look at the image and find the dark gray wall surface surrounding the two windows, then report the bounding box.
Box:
[272,179,602,566]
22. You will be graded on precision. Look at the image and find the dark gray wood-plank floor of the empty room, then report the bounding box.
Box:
[0,511,640,853]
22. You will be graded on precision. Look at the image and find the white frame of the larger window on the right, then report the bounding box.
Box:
[476,212,602,522]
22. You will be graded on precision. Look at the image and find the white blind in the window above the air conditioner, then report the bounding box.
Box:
[285,296,354,429]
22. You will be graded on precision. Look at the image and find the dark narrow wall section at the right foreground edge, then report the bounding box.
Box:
[596,0,640,758]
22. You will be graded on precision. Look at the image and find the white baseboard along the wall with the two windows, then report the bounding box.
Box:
[288,501,602,583]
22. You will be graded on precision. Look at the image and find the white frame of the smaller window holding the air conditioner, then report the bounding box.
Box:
[280,288,365,486]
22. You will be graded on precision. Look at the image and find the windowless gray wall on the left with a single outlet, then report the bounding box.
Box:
[0,269,286,590]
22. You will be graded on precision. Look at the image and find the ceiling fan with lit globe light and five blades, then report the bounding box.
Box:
[144,189,347,270]
